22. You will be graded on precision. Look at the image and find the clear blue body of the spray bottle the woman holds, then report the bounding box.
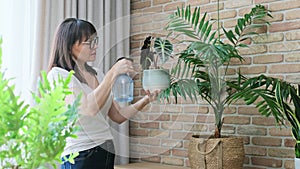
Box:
[112,74,133,102]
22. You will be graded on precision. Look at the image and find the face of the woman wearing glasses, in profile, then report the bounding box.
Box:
[72,35,98,63]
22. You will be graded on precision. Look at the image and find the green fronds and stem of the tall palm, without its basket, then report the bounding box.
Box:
[158,3,294,138]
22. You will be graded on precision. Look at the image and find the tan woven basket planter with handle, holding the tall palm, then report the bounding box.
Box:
[188,135,245,169]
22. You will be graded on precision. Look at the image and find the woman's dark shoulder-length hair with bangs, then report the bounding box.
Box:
[48,18,97,83]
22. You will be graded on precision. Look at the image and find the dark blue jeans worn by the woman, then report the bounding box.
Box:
[61,140,115,169]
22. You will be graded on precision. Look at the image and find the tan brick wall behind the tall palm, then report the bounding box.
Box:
[130,0,300,169]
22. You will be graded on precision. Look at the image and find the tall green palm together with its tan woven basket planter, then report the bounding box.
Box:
[156,2,292,169]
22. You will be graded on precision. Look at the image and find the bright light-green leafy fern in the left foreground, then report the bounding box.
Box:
[0,38,79,169]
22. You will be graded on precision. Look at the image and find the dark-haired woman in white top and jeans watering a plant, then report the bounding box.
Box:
[48,18,157,169]
